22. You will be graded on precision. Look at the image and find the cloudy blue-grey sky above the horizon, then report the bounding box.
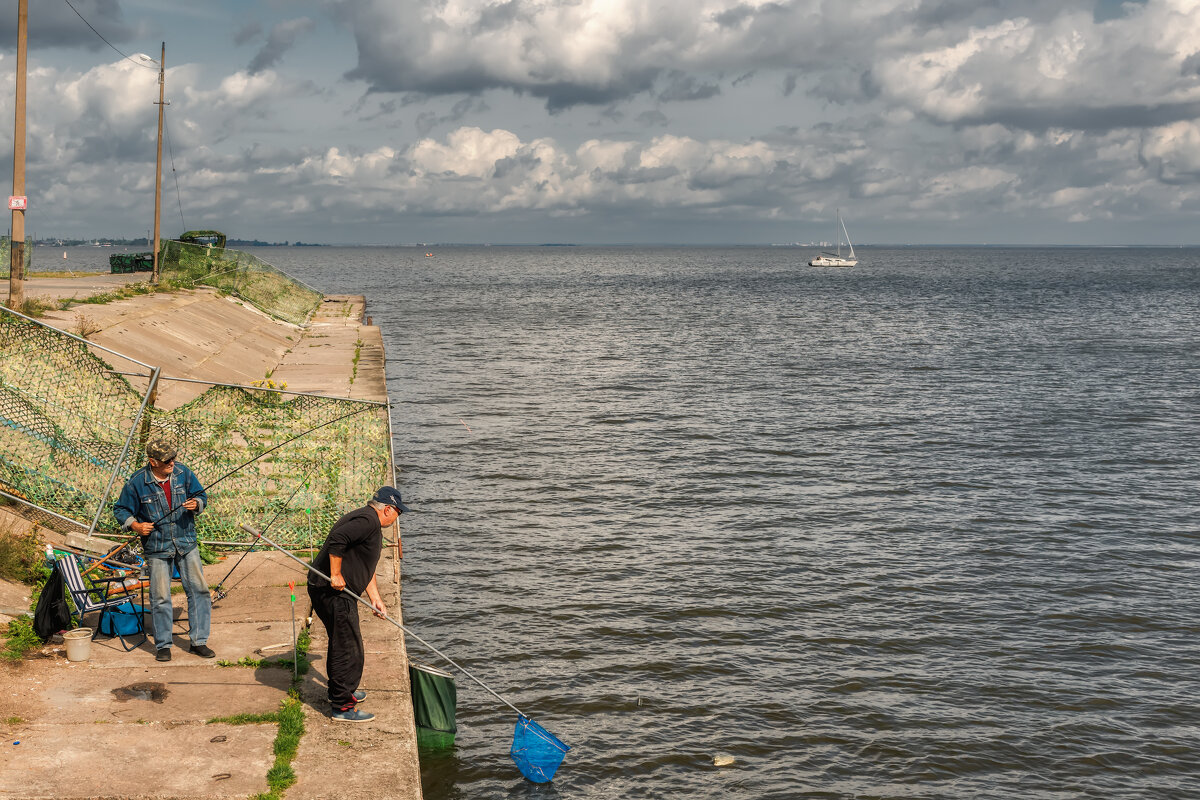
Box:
[0,0,1200,245]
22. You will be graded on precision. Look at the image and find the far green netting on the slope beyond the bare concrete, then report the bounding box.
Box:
[158,241,322,325]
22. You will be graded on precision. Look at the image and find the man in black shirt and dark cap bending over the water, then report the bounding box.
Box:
[308,486,409,722]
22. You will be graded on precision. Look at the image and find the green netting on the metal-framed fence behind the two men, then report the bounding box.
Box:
[0,309,391,546]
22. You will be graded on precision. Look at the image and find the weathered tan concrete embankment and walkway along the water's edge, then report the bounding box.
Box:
[0,276,421,800]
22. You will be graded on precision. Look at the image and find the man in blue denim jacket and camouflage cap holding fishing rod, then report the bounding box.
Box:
[113,438,216,661]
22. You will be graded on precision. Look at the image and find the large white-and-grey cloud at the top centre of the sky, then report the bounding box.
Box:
[335,0,784,113]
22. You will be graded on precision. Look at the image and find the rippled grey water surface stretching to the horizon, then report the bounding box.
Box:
[256,247,1200,800]
